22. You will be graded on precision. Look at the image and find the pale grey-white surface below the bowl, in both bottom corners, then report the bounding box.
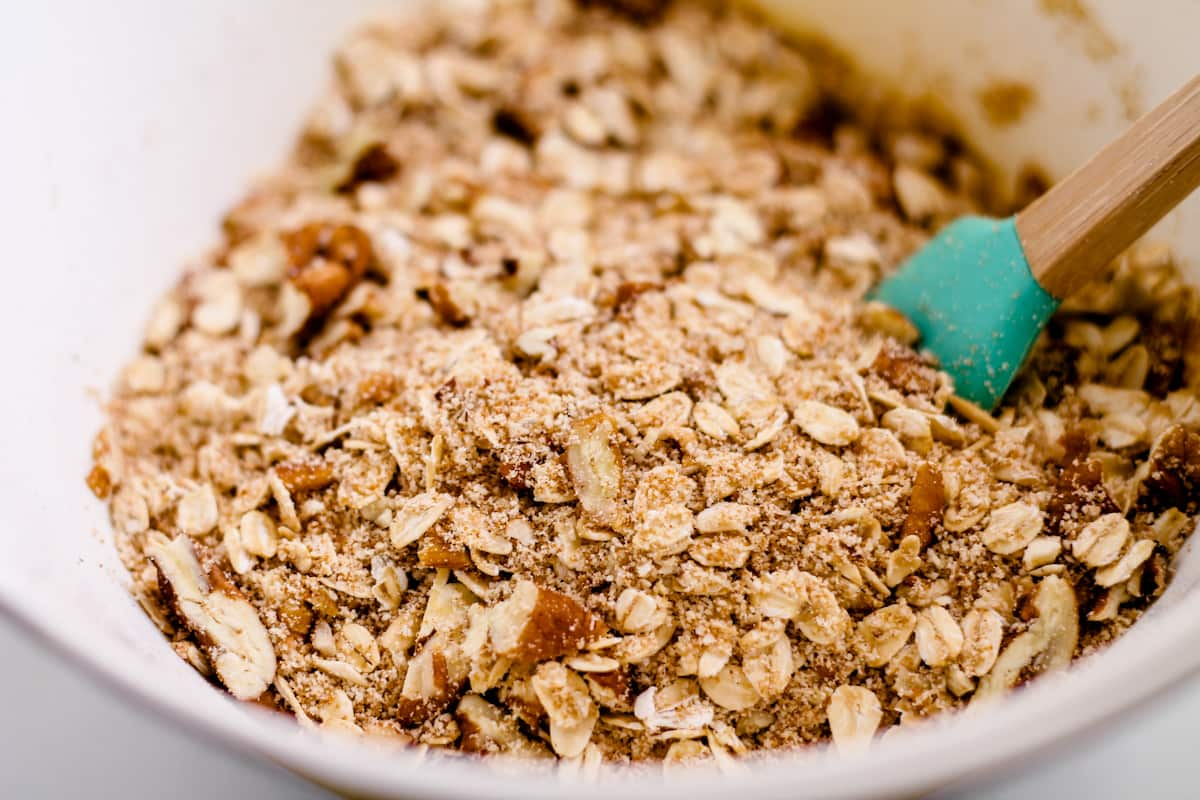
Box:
[0,620,1200,800]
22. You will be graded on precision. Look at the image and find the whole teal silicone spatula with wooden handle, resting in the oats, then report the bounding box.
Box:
[871,76,1200,410]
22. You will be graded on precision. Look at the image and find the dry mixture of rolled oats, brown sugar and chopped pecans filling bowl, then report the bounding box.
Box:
[89,0,1200,765]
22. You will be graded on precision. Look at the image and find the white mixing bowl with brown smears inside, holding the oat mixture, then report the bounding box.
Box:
[0,0,1200,800]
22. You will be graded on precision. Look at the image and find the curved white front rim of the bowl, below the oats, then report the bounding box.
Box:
[0,556,1200,800]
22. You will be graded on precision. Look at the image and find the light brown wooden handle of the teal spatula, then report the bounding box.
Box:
[1016,76,1200,299]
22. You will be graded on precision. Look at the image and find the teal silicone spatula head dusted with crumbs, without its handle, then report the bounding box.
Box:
[871,217,1058,410]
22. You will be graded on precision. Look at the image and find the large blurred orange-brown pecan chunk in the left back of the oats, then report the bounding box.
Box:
[283,222,374,319]
